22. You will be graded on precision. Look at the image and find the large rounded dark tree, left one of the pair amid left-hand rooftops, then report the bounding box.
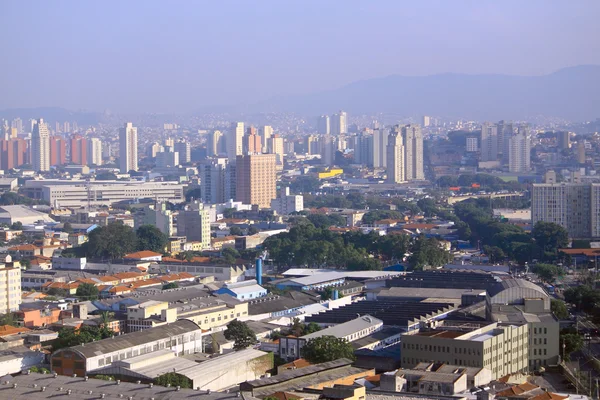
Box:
[85,223,137,260]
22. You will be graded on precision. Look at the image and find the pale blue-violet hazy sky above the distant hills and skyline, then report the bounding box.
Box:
[0,0,600,112]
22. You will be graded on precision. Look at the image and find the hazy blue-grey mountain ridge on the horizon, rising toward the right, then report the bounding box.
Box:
[253,65,600,121]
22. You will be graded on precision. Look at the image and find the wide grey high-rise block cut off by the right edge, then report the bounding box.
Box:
[531,183,600,238]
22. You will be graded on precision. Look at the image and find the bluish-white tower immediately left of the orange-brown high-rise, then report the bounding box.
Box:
[199,157,236,204]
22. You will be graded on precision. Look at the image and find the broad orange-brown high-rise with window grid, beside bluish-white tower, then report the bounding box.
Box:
[236,154,277,208]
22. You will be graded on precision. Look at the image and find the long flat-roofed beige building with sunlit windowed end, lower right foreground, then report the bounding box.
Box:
[401,322,529,379]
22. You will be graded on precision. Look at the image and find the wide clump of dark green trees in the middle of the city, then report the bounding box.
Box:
[264,221,450,271]
